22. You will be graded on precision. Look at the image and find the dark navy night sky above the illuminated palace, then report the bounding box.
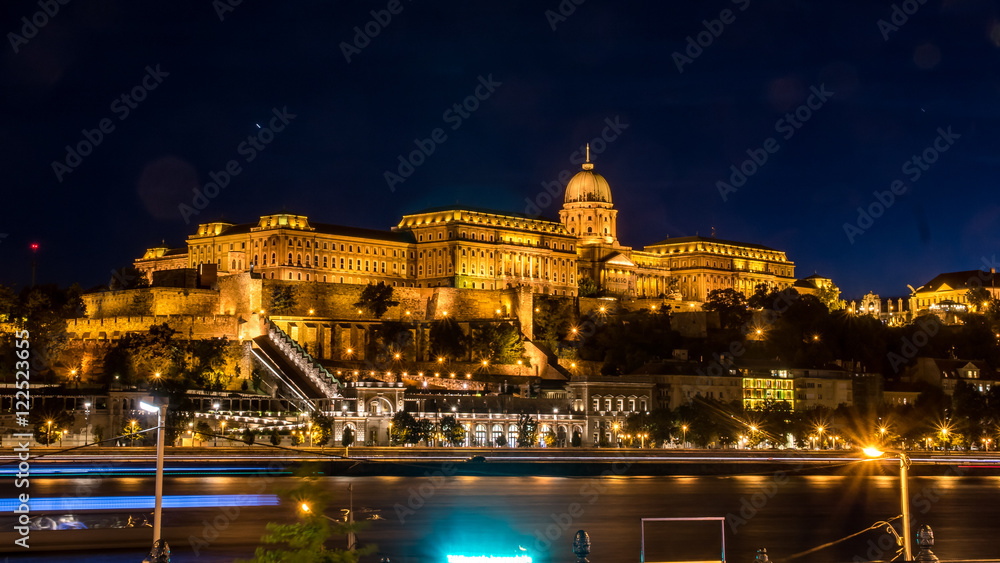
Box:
[0,0,1000,298]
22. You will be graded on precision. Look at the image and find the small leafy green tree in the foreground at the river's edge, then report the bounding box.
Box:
[240,477,377,563]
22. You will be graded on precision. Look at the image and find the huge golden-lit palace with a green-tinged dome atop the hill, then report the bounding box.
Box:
[135,149,795,302]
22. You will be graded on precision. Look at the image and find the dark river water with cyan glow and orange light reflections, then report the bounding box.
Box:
[0,469,1000,563]
